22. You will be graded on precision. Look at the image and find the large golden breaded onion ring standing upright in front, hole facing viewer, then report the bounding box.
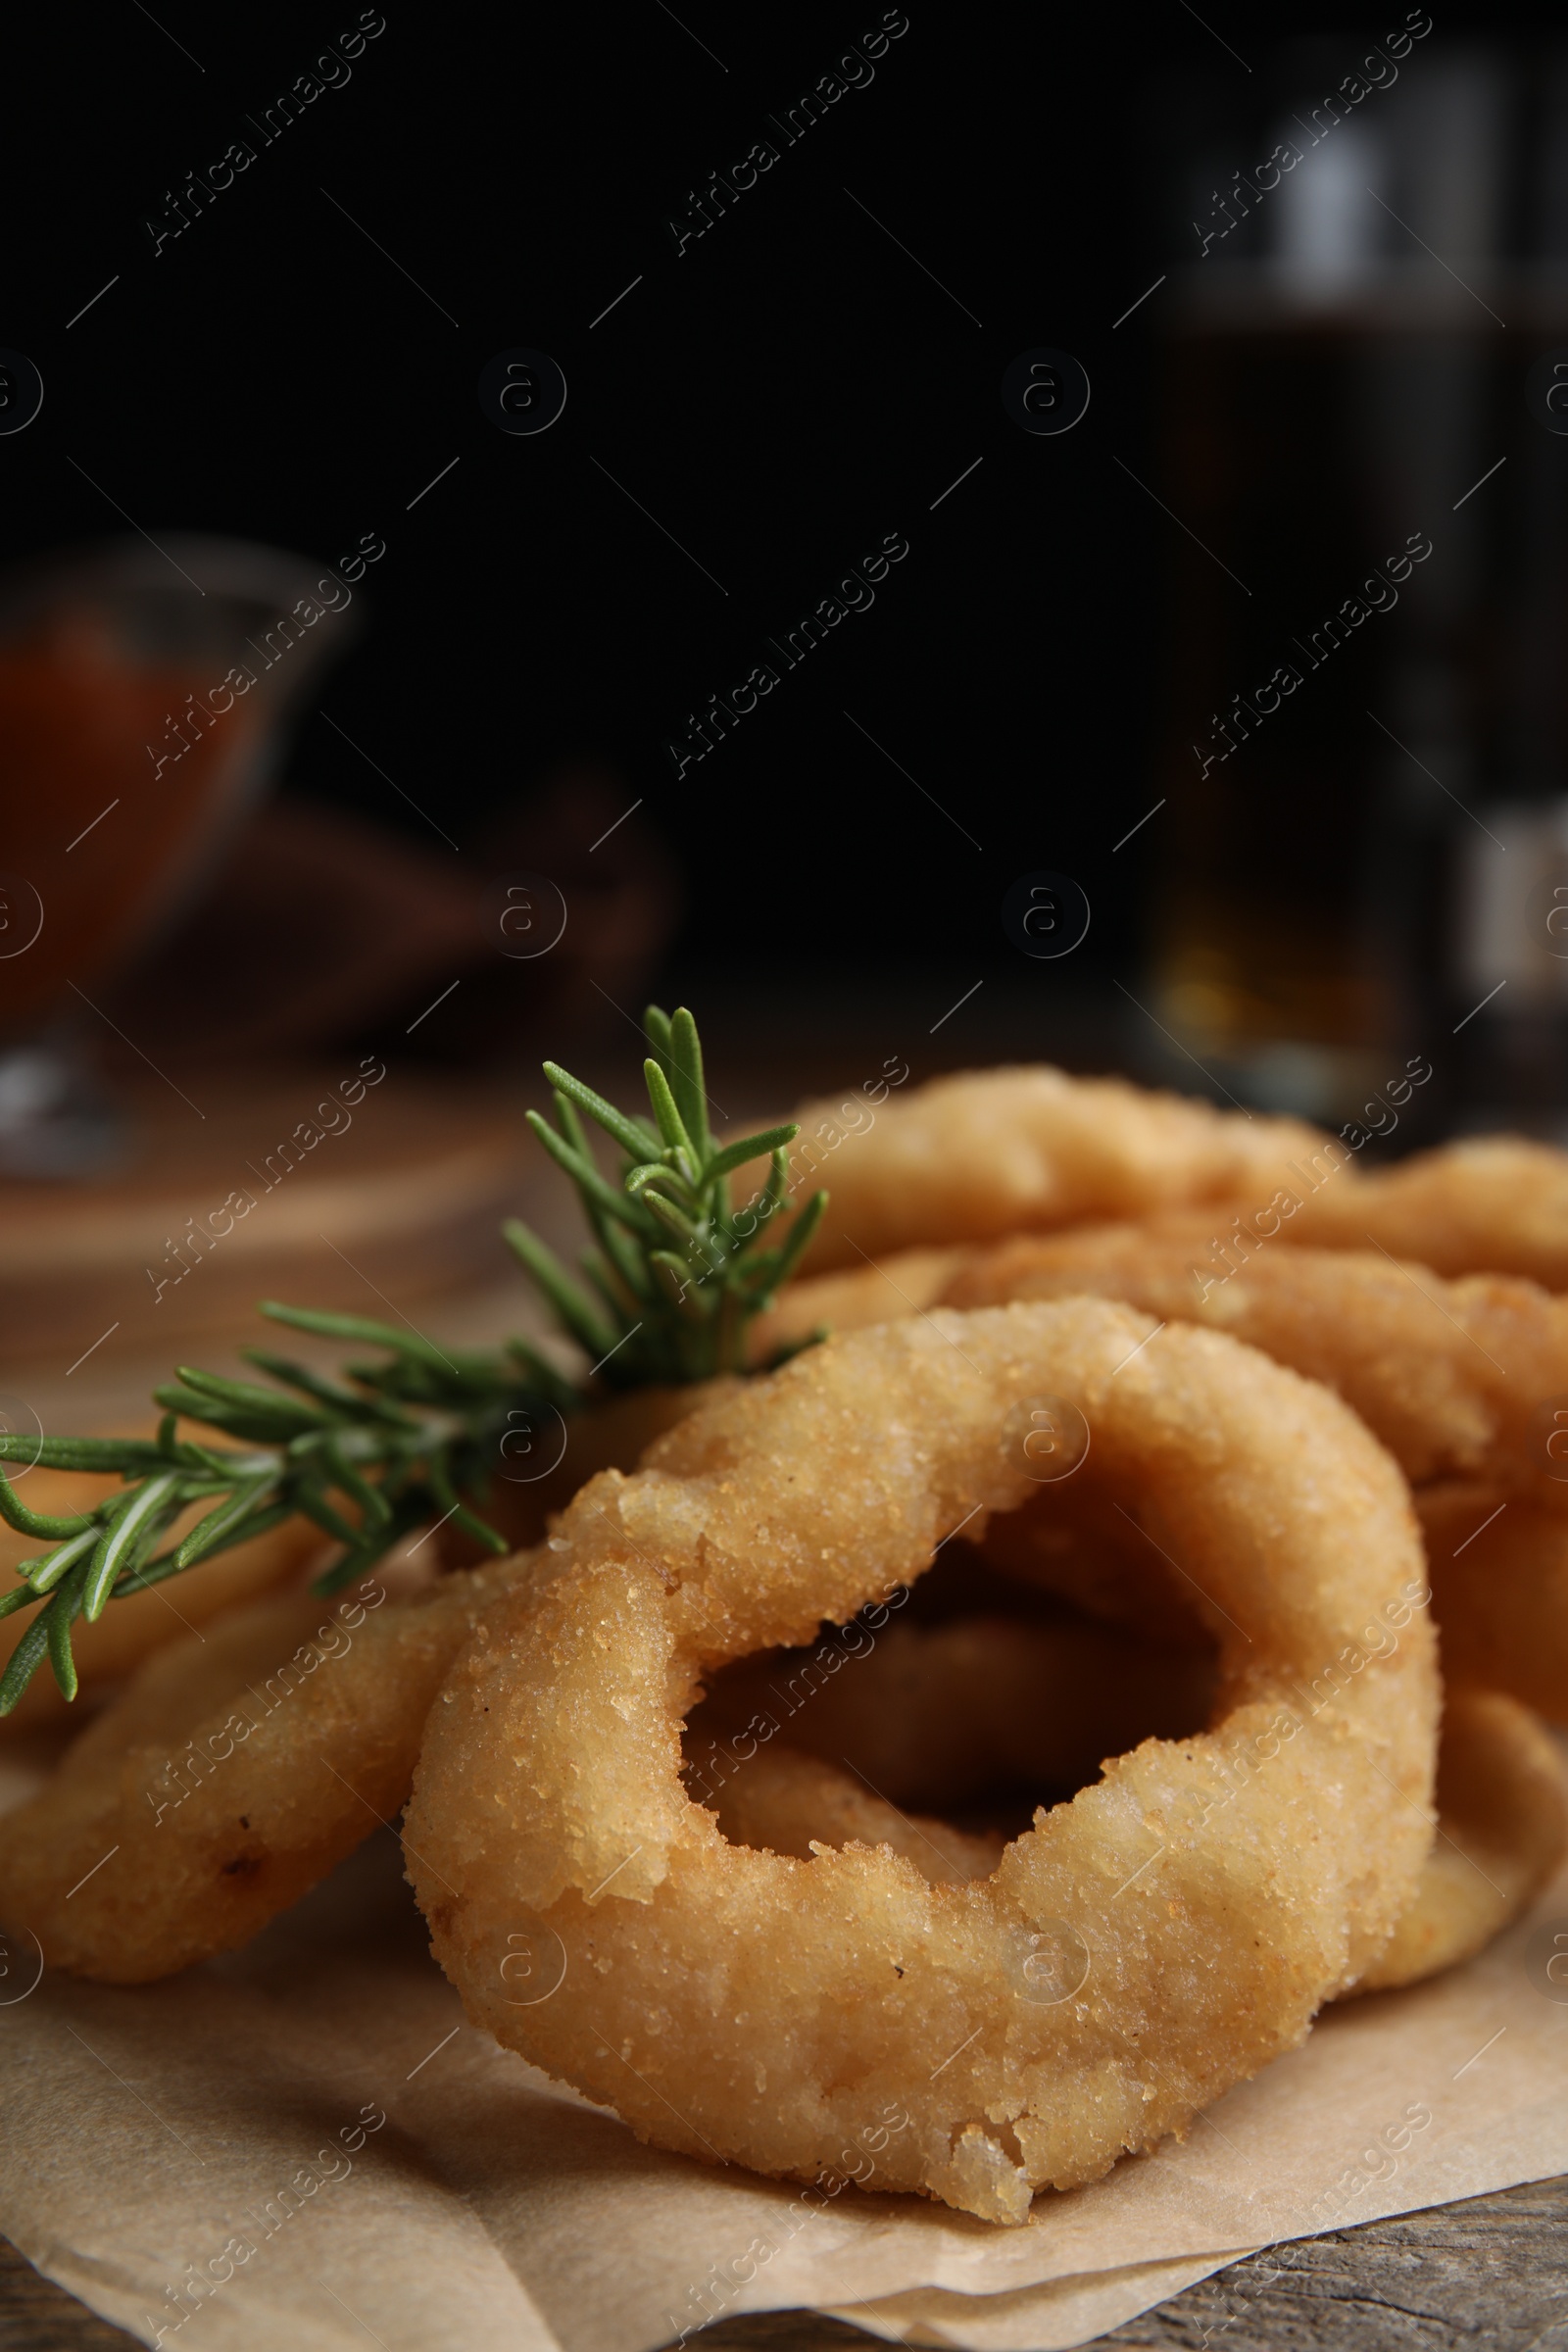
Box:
[407,1300,1437,2221]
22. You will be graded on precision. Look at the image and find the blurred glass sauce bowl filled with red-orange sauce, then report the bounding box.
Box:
[0,536,360,1178]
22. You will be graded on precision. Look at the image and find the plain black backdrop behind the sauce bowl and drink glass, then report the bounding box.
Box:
[0,0,1563,1084]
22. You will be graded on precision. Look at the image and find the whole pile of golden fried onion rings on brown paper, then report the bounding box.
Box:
[0,1070,1568,2221]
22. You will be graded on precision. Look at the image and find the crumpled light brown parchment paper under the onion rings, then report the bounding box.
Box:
[0,1759,1568,2352]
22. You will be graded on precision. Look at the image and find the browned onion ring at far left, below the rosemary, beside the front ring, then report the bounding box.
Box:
[0,1562,519,1985]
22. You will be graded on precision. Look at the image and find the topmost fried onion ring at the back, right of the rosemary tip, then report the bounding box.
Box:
[790,1063,1359,1268]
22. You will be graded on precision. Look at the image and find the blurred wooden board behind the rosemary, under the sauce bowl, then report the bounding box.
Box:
[0,1072,541,1376]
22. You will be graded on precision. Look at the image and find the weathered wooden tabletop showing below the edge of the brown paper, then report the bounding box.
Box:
[0,2178,1568,2352]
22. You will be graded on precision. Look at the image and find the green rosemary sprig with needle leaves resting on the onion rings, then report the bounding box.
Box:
[0,1006,827,1715]
